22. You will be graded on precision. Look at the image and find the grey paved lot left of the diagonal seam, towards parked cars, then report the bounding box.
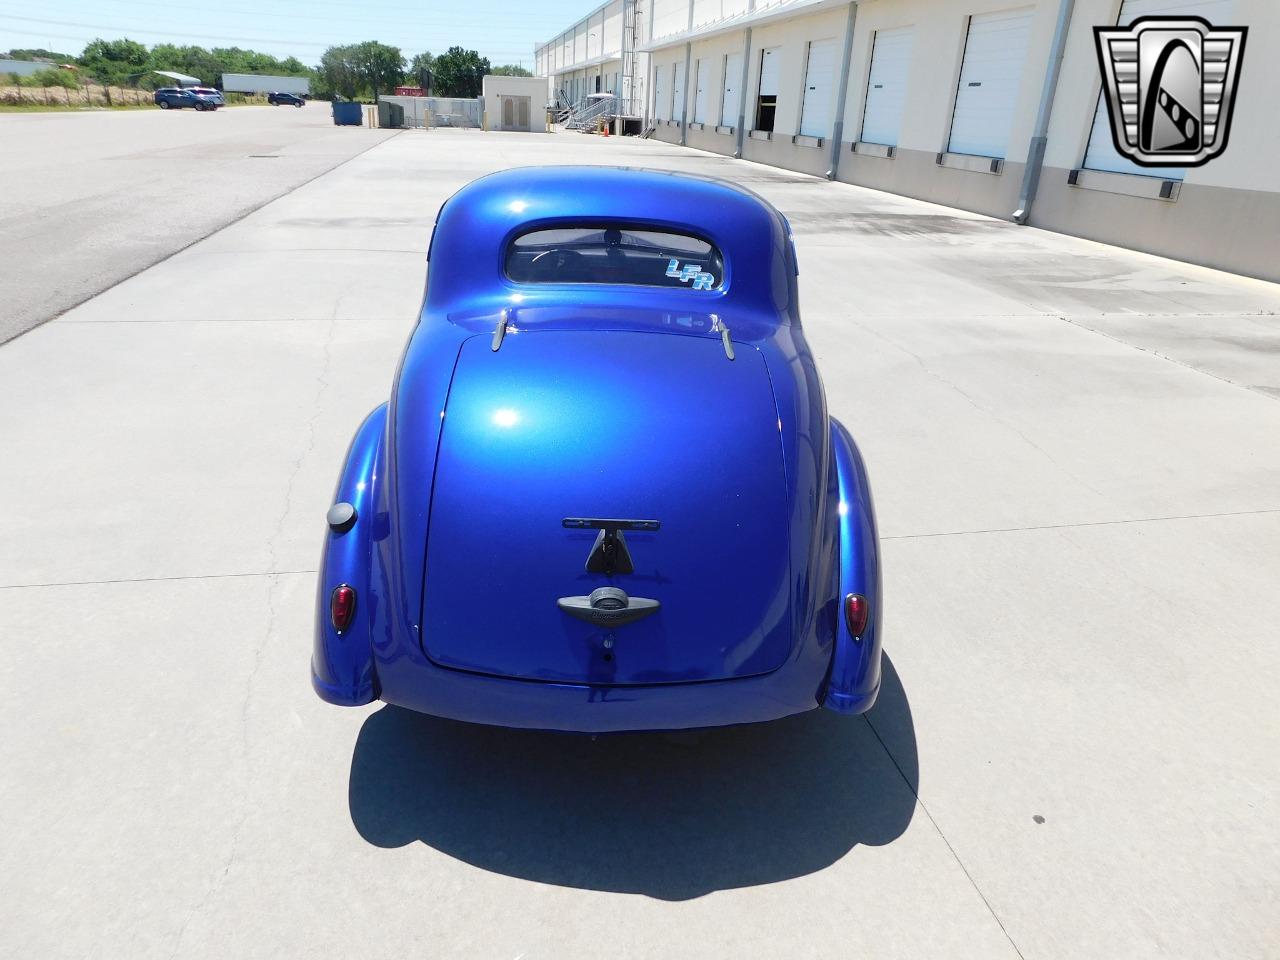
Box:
[0,102,394,343]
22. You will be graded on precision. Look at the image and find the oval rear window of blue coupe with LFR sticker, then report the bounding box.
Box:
[506,224,724,291]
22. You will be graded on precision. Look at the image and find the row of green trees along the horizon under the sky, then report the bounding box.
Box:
[0,38,532,100]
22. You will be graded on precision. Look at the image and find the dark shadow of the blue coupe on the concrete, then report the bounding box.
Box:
[349,657,919,900]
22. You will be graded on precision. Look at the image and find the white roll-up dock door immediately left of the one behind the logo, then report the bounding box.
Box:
[947,9,1034,157]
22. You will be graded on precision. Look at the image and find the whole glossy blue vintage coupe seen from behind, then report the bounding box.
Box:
[311,168,881,732]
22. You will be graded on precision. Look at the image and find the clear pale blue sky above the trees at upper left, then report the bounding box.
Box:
[0,0,588,69]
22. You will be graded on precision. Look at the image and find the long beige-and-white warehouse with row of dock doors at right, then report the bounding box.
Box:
[540,0,1280,280]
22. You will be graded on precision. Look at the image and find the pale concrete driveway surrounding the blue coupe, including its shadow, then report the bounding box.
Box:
[0,128,1280,960]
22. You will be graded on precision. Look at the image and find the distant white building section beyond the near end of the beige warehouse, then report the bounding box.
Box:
[534,0,652,115]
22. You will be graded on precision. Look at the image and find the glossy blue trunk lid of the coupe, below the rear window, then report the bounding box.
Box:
[422,330,791,684]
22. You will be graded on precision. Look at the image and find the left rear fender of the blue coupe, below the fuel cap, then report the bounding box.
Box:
[311,403,387,707]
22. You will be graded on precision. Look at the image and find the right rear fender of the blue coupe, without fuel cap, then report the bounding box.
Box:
[820,417,881,713]
